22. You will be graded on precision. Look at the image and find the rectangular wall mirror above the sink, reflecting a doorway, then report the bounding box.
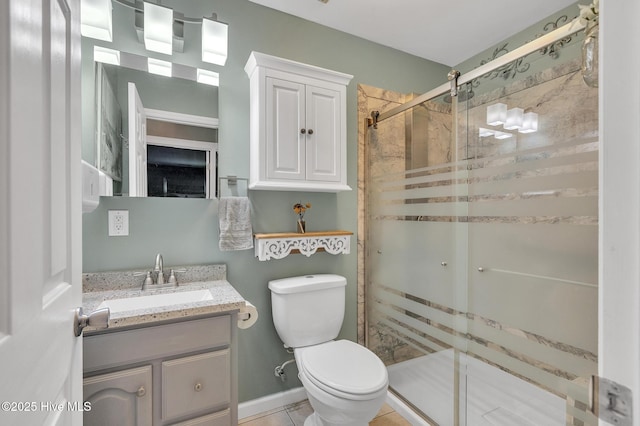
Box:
[95,62,218,198]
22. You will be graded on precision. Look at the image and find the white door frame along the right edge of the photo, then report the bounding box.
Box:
[598,1,640,426]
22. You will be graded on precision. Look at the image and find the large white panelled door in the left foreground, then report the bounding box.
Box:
[0,0,82,425]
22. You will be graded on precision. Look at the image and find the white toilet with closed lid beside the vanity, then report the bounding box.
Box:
[269,274,389,426]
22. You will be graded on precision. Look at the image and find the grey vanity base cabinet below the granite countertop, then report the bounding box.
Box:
[83,313,238,426]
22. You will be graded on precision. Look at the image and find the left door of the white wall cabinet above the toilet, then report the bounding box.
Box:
[265,78,307,181]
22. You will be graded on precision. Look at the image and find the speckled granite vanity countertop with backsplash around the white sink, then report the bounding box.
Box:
[82,265,245,332]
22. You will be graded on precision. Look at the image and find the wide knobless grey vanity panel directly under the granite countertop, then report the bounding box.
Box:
[83,315,231,372]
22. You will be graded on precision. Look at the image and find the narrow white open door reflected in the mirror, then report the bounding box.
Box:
[128,83,147,197]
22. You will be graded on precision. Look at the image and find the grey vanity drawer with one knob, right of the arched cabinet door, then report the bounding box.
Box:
[162,349,231,421]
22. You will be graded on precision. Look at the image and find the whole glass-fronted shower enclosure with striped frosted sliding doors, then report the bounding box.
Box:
[361,24,599,426]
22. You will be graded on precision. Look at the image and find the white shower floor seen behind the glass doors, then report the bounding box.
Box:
[388,349,566,426]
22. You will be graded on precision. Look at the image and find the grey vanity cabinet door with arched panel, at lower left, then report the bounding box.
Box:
[83,365,153,426]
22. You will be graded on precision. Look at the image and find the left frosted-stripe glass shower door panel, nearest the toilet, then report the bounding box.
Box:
[365,88,467,425]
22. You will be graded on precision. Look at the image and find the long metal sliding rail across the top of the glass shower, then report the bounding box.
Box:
[377,21,584,123]
